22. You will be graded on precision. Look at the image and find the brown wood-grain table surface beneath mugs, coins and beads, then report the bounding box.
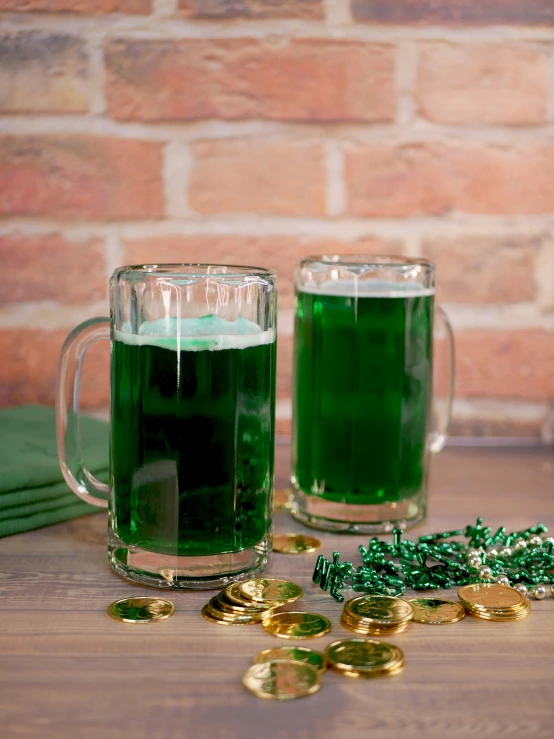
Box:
[0,447,554,739]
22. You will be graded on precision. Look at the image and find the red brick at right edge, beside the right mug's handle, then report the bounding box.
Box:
[455,329,554,400]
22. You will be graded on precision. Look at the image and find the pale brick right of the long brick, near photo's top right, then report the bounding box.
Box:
[416,43,548,125]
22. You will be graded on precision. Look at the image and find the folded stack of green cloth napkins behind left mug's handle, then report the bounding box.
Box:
[0,405,109,537]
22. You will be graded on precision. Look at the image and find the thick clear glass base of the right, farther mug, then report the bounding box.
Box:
[290,488,427,534]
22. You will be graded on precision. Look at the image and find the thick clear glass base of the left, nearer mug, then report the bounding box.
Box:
[108,532,269,590]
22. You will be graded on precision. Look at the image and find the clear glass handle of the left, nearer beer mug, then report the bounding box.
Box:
[56,318,110,508]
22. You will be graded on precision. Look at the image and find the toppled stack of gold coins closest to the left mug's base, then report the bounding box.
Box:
[202,578,304,626]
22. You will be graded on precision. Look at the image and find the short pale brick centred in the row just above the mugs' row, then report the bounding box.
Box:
[189,140,325,216]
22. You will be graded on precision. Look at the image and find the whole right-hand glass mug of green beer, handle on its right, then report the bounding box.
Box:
[292,254,453,533]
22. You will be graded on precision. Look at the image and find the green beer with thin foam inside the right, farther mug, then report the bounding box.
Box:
[293,280,434,525]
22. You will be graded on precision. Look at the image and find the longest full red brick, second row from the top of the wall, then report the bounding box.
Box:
[105,39,395,122]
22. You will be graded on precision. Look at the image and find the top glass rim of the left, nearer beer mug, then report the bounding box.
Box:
[113,262,277,280]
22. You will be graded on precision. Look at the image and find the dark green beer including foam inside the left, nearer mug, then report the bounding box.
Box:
[111,315,275,556]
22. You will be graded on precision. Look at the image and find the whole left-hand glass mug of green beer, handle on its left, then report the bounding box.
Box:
[57,264,277,588]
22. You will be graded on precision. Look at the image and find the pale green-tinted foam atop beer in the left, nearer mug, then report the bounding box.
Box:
[114,315,275,352]
